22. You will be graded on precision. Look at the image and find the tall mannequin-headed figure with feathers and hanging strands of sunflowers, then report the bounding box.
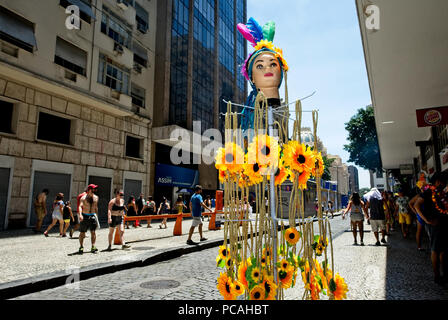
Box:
[215,18,348,300]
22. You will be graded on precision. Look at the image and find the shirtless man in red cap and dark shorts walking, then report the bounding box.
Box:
[78,184,98,254]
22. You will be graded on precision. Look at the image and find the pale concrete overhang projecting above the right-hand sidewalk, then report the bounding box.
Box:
[356,0,448,169]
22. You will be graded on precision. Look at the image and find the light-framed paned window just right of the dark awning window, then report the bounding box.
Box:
[98,54,130,94]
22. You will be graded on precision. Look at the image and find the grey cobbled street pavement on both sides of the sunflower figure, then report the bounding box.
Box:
[10,216,448,300]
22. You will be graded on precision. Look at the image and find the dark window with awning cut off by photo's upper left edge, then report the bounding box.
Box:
[0,7,37,52]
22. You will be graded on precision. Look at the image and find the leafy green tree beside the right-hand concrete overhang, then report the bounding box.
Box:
[344,106,382,171]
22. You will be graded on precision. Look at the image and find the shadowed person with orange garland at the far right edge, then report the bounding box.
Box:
[414,172,448,284]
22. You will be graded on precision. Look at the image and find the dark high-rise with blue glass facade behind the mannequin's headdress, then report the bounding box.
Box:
[151,0,247,200]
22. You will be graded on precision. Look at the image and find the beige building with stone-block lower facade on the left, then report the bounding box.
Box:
[0,0,156,230]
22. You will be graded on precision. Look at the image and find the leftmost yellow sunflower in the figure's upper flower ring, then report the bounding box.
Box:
[215,142,244,174]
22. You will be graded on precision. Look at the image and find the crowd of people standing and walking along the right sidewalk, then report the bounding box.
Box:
[342,173,448,284]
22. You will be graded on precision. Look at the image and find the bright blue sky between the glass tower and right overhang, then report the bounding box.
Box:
[247,0,371,188]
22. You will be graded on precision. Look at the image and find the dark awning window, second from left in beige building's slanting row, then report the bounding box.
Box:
[54,37,87,76]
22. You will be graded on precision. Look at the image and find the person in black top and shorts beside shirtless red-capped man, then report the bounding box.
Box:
[106,190,131,251]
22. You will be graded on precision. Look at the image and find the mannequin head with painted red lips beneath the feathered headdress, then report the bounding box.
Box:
[252,52,281,98]
